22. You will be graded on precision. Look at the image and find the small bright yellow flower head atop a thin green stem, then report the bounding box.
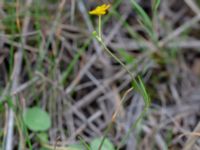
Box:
[89,4,110,16]
